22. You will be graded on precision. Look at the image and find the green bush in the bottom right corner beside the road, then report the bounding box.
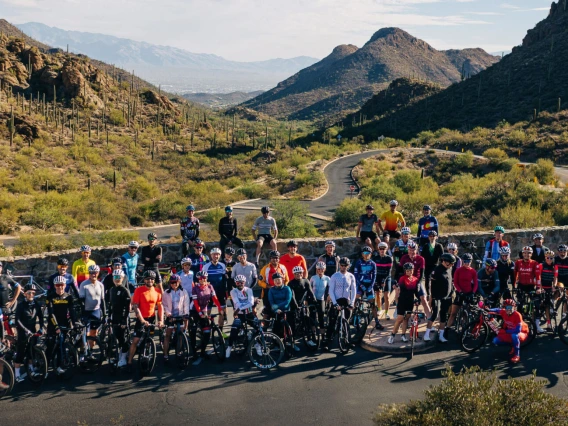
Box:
[374,367,568,426]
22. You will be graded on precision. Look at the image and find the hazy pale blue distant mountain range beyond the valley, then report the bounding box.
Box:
[17,22,318,93]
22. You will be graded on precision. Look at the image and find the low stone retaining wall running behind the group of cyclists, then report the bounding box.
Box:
[0,226,568,279]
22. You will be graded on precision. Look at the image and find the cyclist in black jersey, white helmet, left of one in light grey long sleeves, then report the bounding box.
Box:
[45,275,76,374]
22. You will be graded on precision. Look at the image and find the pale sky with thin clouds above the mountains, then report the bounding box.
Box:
[0,0,552,61]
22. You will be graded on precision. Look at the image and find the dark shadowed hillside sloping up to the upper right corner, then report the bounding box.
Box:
[344,0,568,139]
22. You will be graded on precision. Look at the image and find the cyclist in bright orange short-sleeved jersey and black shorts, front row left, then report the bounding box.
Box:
[127,270,164,371]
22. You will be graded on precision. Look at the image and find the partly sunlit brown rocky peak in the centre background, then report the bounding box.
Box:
[243,28,499,122]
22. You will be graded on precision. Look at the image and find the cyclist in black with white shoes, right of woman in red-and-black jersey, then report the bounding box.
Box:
[424,253,456,343]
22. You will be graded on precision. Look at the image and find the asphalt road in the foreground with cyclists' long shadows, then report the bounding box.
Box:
[0,330,568,426]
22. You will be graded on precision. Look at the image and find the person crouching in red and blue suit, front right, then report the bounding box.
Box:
[489,299,529,363]
